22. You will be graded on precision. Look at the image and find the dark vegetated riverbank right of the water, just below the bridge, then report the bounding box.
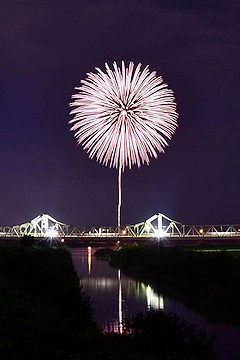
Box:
[111,245,240,326]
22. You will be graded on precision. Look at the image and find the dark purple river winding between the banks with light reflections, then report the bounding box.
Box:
[72,247,240,360]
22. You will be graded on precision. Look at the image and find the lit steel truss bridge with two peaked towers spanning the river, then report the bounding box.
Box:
[0,213,240,239]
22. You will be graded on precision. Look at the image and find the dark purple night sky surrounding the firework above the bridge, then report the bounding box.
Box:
[0,0,240,225]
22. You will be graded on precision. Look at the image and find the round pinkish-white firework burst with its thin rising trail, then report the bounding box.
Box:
[69,62,178,226]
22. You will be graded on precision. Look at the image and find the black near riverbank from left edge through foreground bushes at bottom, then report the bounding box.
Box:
[0,246,215,360]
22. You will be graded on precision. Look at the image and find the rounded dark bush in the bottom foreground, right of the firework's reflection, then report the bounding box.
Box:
[126,311,215,360]
